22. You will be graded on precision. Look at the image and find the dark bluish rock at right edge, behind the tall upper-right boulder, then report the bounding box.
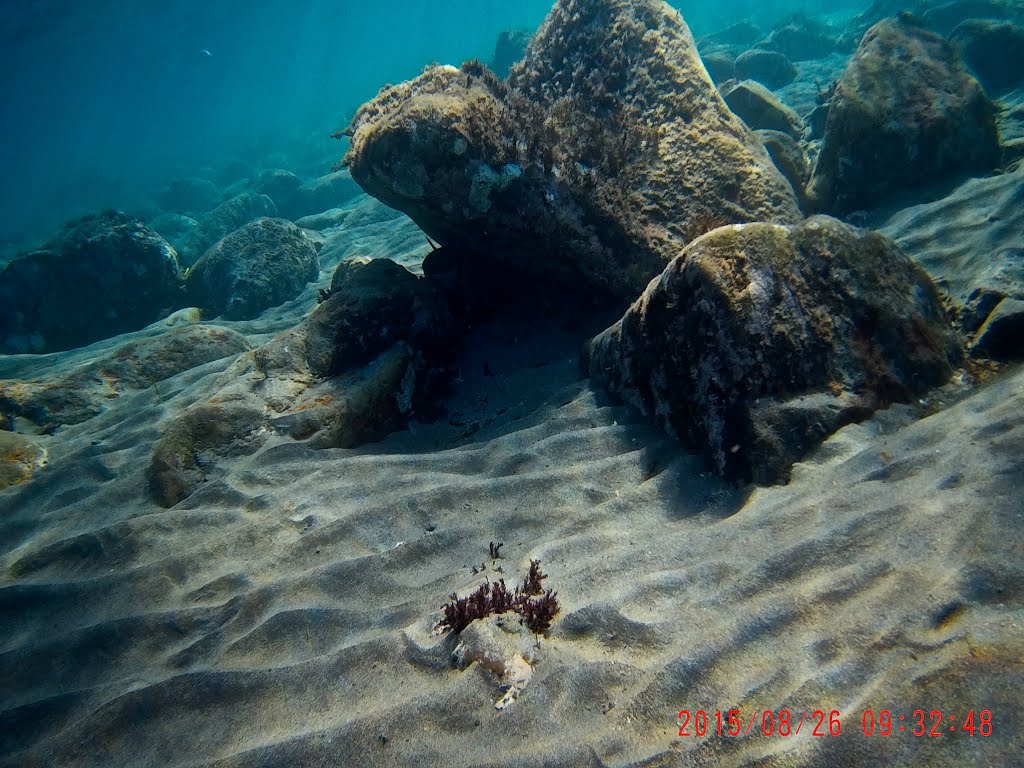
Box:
[949,18,1024,92]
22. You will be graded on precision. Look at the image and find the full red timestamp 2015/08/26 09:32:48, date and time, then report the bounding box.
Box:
[677,710,992,738]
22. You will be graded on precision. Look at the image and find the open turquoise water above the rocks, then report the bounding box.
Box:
[0,0,861,244]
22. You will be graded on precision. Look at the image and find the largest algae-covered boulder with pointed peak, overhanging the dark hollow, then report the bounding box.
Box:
[345,0,800,301]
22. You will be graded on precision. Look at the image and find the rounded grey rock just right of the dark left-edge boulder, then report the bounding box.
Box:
[185,218,319,319]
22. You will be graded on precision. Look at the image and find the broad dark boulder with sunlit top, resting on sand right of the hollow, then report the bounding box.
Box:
[588,216,963,482]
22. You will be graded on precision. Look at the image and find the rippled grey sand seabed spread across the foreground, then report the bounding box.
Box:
[0,193,1024,768]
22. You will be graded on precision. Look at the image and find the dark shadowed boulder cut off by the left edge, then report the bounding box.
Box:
[0,211,181,354]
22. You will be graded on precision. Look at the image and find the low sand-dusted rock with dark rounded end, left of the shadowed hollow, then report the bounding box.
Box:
[148,259,451,507]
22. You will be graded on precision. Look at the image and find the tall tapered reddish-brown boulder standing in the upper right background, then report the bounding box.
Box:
[808,20,999,214]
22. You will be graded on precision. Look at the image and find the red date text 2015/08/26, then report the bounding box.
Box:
[677,710,843,738]
